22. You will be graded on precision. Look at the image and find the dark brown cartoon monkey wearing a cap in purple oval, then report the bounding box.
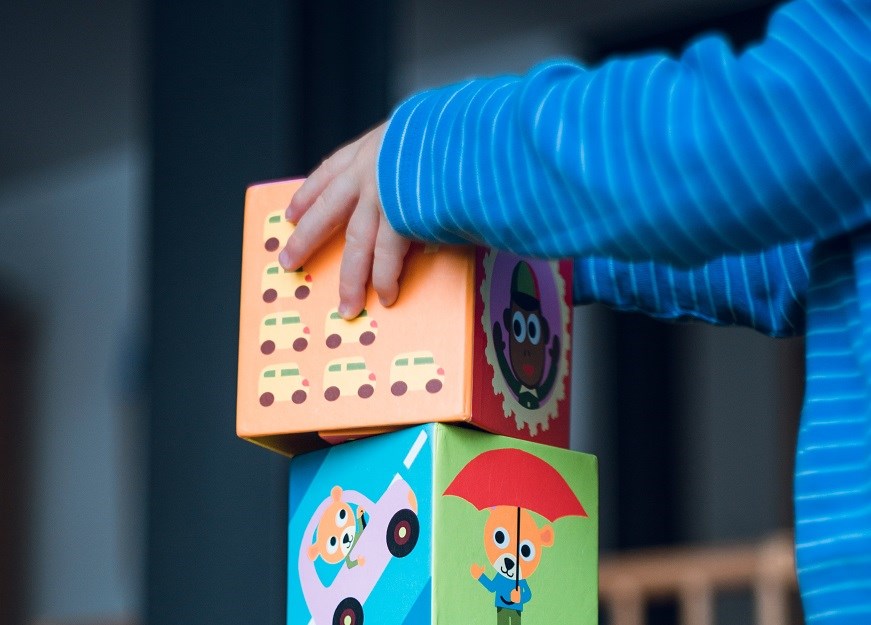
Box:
[493,261,560,410]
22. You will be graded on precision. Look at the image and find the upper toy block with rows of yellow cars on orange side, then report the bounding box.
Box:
[237,180,572,455]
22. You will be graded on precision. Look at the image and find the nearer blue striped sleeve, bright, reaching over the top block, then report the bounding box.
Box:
[378,0,871,271]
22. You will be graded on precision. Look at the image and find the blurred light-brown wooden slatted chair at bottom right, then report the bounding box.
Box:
[599,533,797,625]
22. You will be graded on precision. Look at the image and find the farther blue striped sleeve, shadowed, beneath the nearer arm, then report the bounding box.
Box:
[574,242,812,337]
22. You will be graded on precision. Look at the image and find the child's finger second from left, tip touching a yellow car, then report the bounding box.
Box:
[278,176,357,270]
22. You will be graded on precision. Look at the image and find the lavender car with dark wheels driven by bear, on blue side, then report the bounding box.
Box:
[298,474,420,625]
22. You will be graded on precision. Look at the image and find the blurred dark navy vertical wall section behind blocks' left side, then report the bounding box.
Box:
[144,0,390,625]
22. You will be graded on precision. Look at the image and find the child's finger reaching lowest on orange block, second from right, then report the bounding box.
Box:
[339,198,379,319]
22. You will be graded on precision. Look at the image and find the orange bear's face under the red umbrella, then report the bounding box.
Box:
[484,506,554,579]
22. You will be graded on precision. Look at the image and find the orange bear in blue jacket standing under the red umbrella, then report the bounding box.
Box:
[470,506,554,625]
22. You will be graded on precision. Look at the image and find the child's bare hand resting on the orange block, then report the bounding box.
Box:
[278,124,410,319]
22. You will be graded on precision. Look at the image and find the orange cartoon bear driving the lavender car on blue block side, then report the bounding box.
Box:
[308,486,366,569]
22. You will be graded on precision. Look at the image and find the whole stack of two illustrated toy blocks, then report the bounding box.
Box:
[237,180,598,625]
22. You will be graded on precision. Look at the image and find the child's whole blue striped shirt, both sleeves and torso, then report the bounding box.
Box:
[378,0,871,624]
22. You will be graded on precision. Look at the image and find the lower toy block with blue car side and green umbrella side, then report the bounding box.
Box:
[287,423,599,625]
